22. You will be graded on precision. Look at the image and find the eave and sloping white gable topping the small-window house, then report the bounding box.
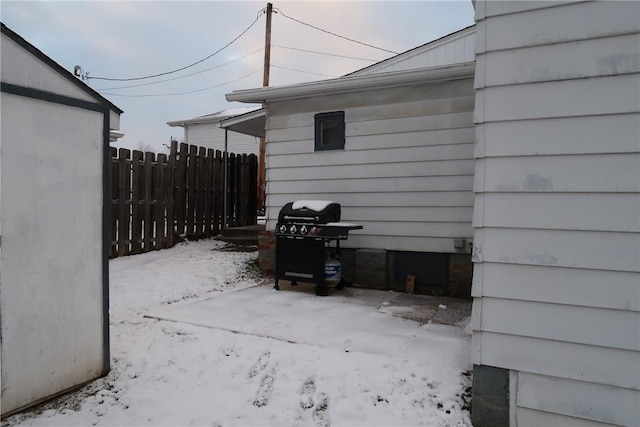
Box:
[226,26,475,103]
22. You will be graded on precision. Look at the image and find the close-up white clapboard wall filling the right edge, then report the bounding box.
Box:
[472,2,640,427]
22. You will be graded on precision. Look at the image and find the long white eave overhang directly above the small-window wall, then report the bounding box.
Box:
[225,62,475,103]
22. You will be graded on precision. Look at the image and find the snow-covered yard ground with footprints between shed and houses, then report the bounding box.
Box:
[3,240,471,427]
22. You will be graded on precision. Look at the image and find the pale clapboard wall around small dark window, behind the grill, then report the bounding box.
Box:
[267,79,474,253]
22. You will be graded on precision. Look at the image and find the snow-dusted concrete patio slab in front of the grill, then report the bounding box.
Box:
[146,285,468,358]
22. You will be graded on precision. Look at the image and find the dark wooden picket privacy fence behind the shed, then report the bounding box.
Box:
[109,141,258,258]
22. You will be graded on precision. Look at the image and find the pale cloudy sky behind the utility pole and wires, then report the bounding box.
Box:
[0,0,473,150]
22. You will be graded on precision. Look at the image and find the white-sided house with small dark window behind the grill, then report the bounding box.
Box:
[227,26,475,296]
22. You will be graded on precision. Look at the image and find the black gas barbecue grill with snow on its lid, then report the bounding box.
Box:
[274,200,362,295]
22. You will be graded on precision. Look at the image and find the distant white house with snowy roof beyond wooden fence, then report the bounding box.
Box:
[167,106,260,154]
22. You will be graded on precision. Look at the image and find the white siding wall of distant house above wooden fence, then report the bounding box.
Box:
[185,122,260,154]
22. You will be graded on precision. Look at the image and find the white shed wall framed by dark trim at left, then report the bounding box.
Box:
[0,93,103,413]
